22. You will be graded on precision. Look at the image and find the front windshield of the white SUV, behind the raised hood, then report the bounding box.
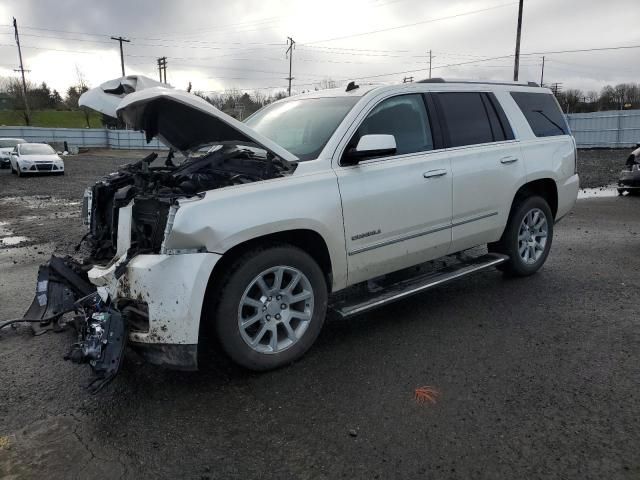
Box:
[246,97,360,161]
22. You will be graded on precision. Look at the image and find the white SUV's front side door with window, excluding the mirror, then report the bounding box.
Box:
[336,93,451,284]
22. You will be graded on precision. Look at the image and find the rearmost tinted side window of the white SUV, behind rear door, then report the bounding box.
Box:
[511,92,569,137]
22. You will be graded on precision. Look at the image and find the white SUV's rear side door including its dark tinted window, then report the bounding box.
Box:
[432,92,525,252]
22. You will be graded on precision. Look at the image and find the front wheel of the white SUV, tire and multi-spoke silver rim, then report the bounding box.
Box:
[209,245,328,371]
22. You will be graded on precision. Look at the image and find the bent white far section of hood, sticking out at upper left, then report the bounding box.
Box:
[78,75,173,118]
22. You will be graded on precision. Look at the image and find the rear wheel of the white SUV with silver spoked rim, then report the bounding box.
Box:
[489,196,554,277]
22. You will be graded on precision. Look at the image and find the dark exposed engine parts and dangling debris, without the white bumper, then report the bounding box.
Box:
[14,142,295,393]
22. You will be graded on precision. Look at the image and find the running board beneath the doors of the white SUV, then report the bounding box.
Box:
[329,253,509,318]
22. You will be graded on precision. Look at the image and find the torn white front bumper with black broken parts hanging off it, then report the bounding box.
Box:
[25,253,220,392]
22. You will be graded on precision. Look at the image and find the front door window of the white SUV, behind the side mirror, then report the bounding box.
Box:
[347,94,433,155]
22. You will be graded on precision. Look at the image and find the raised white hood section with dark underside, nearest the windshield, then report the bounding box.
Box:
[114,86,298,162]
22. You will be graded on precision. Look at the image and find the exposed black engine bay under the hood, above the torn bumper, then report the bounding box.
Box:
[83,145,295,263]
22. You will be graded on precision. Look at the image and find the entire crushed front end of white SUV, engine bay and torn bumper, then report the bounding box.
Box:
[25,145,291,391]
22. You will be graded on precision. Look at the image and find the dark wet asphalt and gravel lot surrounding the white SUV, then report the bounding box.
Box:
[0,148,640,479]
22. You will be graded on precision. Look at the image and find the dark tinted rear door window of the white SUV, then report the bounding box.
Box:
[435,92,494,147]
